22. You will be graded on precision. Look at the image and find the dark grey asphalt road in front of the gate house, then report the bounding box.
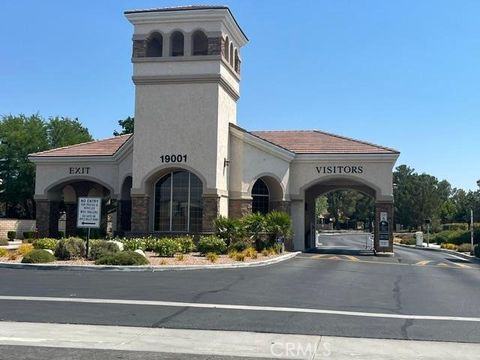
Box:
[0,232,480,343]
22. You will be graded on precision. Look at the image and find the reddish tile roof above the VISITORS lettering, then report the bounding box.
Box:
[251,130,398,154]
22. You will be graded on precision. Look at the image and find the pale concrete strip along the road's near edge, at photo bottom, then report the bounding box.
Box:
[0,322,480,360]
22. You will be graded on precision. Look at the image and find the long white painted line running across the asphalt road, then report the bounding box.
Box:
[0,296,480,322]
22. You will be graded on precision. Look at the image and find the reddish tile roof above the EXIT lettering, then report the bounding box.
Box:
[30,134,132,157]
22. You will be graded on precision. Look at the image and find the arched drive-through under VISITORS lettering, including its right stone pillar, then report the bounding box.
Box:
[305,178,393,254]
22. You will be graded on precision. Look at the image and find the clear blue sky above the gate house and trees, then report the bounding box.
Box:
[0,0,480,189]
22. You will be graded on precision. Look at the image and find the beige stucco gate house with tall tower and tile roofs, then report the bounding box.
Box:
[30,6,399,252]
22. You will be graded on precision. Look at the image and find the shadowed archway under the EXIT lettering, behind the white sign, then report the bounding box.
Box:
[37,180,117,237]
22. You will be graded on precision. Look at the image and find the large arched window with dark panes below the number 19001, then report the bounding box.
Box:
[155,170,203,232]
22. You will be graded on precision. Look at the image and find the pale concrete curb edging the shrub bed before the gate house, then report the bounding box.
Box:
[0,251,301,272]
